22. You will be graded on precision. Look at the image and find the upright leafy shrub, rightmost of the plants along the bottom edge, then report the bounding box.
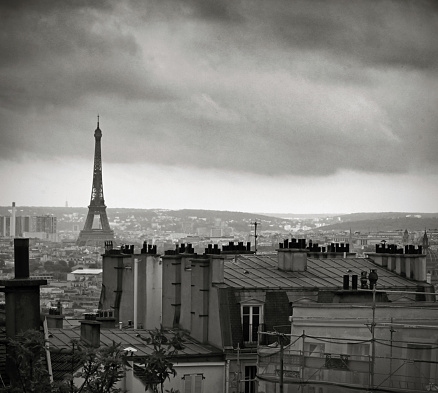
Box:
[141,326,184,393]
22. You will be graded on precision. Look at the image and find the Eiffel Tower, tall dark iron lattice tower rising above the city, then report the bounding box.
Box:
[76,116,114,247]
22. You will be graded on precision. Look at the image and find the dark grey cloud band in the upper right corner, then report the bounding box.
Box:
[243,0,438,68]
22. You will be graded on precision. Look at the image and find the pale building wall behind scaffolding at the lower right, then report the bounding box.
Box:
[260,302,438,392]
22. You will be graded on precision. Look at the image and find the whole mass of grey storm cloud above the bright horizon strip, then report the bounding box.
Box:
[0,0,438,176]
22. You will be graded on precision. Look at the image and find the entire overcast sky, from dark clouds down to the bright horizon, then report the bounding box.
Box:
[0,0,438,214]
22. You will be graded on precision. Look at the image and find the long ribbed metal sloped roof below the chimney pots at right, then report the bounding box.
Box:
[224,254,418,290]
